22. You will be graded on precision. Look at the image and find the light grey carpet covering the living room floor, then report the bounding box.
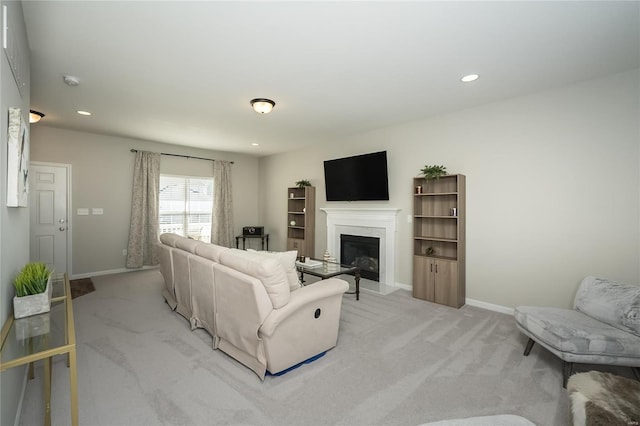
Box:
[21,270,580,426]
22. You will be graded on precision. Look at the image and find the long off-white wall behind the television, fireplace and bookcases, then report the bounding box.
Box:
[260,70,640,307]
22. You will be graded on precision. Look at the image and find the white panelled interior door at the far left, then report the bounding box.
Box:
[29,163,71,274]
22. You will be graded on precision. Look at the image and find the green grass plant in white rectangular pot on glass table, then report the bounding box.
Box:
[13,262,52,319]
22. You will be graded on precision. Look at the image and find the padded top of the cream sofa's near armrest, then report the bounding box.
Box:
[260,278,349,336]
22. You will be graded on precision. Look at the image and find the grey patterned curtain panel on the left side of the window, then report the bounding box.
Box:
[127,151,160,268]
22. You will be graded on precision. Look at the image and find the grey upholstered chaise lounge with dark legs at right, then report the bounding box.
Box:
[514,277,640,387]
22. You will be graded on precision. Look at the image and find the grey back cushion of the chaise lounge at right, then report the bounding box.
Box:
[574,277,640,336]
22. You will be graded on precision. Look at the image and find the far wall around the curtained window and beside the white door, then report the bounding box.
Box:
[31,122,258,277]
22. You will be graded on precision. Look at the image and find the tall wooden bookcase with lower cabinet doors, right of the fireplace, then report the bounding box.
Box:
[413,174,466,308]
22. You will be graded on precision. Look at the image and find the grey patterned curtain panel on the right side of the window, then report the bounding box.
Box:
[211,160,234,247]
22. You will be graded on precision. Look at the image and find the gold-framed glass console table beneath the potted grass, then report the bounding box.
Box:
[0,273,78,426]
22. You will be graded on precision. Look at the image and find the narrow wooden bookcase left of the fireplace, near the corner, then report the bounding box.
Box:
[287,186,316,257]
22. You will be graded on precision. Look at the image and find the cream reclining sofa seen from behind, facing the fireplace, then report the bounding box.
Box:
[158,234,349,380]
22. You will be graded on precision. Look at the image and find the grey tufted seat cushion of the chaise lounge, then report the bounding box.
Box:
[514,306,640,363]
